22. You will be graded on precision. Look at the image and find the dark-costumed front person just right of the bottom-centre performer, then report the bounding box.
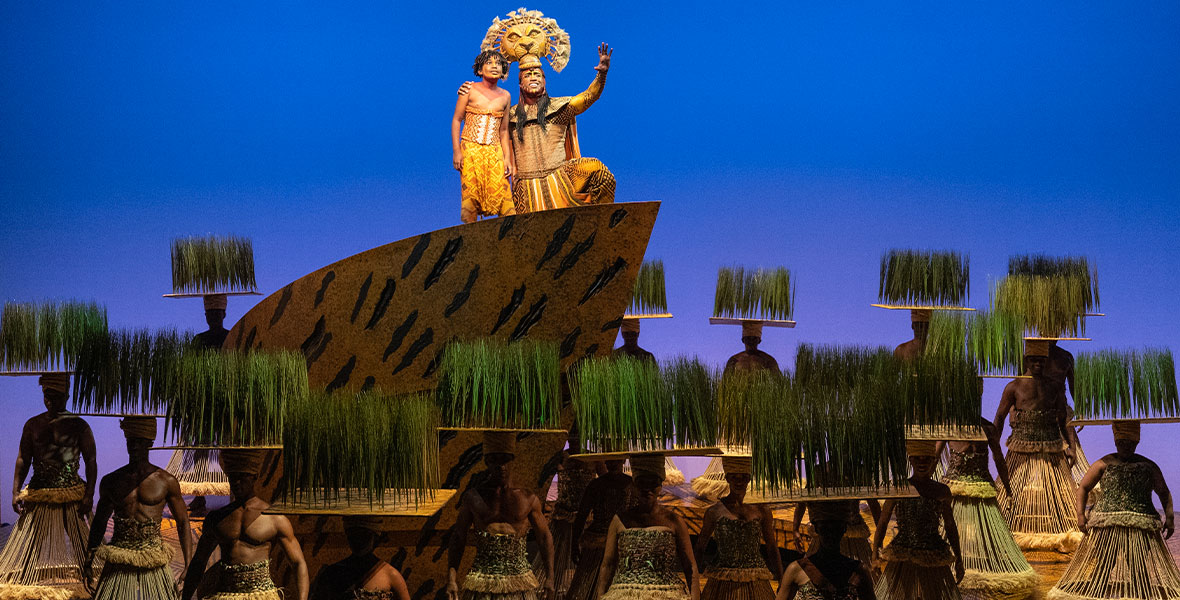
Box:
[695,456,782,600]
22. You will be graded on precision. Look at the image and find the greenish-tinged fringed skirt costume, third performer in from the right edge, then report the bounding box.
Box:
[943,445,1041,600]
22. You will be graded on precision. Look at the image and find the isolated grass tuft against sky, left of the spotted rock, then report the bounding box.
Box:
[172,235,257,294]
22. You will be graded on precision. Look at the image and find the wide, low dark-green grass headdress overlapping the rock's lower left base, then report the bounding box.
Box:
[275,390,441,514]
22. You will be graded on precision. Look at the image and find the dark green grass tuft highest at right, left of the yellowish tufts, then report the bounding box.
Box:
[877,249,970,306]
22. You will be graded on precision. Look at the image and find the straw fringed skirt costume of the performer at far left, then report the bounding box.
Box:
[0,457,89,600]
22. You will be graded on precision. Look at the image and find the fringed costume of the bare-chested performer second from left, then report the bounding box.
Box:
[94,516,177,600]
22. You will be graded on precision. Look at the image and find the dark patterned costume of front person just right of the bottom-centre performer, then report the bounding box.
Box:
[701,517,774,600]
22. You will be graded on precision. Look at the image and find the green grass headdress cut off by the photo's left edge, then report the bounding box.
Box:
[0,301,107,374]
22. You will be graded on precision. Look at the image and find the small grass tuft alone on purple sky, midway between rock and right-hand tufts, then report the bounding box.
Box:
[713,267,795,320]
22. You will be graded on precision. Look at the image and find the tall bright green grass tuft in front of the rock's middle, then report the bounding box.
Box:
[437,339,561,429]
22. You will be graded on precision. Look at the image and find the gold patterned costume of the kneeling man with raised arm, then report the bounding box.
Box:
[510,73,615,213]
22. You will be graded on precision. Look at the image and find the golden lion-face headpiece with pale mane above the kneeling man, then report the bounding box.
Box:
[479,7,570,73]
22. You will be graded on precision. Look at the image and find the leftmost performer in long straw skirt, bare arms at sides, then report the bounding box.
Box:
[0,373,98,600]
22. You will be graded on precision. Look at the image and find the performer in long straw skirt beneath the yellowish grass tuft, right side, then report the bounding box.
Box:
[995,340,1082,553]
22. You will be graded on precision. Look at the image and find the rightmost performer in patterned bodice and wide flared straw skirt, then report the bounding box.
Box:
[1049,420,1180,600]
